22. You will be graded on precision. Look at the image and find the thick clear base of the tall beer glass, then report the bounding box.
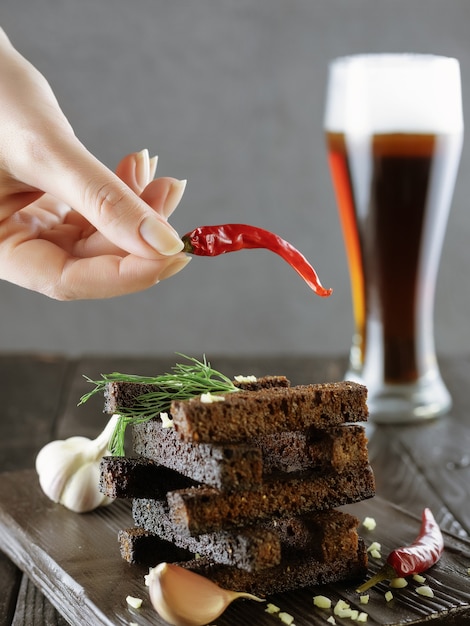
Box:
[344,368,452,424]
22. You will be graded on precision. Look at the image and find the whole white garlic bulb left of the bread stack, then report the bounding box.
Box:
[36,415,118,513]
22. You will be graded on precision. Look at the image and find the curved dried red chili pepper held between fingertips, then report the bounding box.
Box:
[182,224,333,298]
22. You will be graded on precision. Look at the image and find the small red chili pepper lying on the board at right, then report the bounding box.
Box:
[357,509,444,593]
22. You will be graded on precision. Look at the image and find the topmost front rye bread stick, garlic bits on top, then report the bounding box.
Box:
[170,381,368,443]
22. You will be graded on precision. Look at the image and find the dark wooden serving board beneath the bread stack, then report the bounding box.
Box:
[0,470,470,626]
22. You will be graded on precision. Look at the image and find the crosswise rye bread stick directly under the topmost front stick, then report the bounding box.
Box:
[132,419,263,491]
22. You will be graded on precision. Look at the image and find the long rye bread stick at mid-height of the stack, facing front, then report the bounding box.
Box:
[167,464,375,535]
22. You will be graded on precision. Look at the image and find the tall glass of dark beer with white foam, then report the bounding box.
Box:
[325,54,463,423]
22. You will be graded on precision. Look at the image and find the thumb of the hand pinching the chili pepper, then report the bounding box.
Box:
[25,135,183,258]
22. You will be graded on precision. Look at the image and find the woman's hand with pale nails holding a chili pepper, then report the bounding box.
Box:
[0,30,189,300]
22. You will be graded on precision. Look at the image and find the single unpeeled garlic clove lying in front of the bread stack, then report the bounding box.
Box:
[148,563,264,626]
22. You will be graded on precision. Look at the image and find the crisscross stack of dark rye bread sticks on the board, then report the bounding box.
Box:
[100,376,375,595]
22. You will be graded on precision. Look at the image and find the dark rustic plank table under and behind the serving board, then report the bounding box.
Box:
[0,354,470,626]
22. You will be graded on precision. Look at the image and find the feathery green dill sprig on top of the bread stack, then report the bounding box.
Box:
[79,353,239,456]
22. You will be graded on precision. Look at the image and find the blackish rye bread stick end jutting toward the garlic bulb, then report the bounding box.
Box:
[99,456,198,499]
